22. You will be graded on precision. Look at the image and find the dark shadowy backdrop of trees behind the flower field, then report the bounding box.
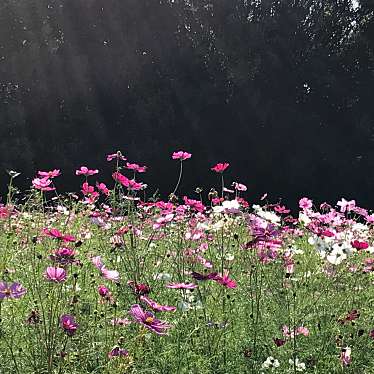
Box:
[0,0,374,208]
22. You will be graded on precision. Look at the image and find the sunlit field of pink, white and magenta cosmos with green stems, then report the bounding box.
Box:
[0,151,374,374]
